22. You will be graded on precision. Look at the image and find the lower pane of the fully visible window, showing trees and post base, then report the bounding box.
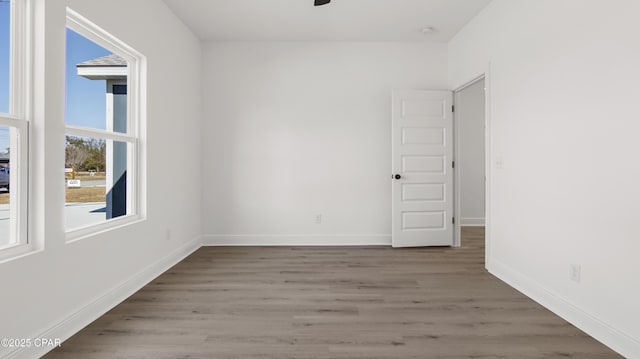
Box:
[65,136,130,229]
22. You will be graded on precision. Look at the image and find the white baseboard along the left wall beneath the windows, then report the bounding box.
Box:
[5,237,202,359]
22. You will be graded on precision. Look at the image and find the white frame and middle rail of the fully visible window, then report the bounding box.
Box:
[65,8,146,242]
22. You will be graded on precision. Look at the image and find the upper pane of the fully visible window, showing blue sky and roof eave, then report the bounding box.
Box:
[65,29,128,133]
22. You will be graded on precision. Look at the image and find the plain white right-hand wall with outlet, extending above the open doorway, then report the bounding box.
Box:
[449,0,640,358]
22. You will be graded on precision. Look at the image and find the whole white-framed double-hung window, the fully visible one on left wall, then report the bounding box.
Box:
[65,10,143,239]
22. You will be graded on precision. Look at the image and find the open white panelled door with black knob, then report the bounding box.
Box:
[391,91,453,247]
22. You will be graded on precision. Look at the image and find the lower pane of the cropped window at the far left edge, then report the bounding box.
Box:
[0,126,15,248]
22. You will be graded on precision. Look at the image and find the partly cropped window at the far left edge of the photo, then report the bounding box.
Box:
[0,0,29,260]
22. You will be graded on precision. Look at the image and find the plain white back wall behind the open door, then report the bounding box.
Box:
[202,42,447,244]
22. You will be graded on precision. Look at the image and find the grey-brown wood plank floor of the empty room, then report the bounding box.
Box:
[46,228,620,359]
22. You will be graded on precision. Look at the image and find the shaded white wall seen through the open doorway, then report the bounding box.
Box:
[455,80,485,226]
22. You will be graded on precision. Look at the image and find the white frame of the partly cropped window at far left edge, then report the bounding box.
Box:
[0,0,30,263]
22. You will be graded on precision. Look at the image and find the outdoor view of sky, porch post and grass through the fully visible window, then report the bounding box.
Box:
[65,29,136,230]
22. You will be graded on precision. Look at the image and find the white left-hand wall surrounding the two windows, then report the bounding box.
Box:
[0,0,201,358]
